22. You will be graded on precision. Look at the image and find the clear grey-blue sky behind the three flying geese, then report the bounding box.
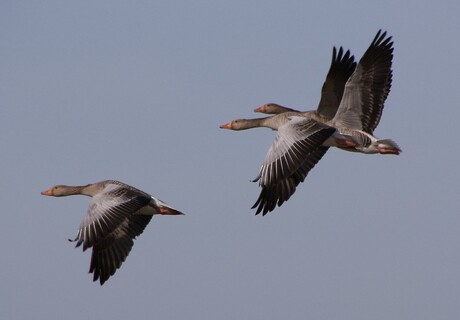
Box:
[0,0,460,320]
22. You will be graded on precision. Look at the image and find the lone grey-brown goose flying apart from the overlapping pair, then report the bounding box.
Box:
[41,180,183,285]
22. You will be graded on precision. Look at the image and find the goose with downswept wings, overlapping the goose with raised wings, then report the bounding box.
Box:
[220,112,356,215]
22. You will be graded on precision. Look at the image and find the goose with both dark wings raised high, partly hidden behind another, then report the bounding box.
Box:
[254,30,401,155]
